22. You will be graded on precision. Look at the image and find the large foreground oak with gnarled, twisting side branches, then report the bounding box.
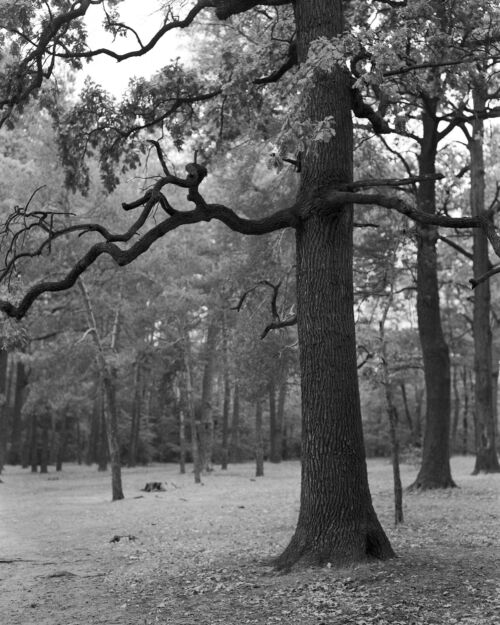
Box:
[0,0,499,569]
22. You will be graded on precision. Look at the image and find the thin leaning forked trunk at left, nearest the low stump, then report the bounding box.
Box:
[78,278,123,501]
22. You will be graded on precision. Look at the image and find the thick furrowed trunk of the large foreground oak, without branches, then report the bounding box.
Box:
[276,0,394,569]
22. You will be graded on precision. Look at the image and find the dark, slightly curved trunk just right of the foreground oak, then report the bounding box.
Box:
[412,107,455,490]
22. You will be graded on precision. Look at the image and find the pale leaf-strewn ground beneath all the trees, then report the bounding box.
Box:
[0,457,500,625]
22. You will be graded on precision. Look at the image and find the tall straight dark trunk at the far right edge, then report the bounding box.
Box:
[469,83,500,475]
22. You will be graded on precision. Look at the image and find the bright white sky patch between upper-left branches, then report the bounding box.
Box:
[77,0,188,96]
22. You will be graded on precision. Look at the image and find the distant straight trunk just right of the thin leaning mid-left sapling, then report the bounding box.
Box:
[200,318,219,472]
